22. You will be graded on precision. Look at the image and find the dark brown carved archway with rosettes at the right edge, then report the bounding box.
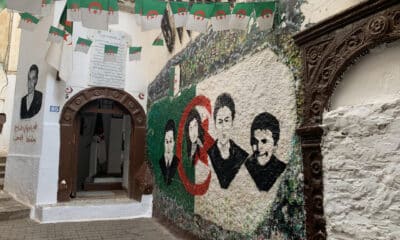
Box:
[294,0,400,240]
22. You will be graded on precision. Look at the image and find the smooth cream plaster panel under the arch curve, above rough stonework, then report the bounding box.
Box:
[330,41,400,110]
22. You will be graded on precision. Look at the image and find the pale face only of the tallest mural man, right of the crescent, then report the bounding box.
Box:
[215,106,233,144]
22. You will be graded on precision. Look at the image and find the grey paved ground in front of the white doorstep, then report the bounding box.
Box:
[0,219,182,240]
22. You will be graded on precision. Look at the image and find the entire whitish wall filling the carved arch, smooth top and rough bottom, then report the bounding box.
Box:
[322,41,400,240]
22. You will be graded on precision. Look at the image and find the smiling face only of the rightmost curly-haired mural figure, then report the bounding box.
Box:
[252,129,275,166]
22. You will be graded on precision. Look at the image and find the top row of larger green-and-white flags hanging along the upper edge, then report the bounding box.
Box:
[7,0,275,33]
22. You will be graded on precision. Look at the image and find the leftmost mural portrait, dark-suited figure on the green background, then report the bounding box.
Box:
[159,119,178,185]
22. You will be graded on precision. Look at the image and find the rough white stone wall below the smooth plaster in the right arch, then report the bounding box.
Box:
[322,98,400,240]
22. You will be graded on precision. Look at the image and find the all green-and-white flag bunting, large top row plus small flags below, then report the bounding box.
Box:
[6,0,275,66]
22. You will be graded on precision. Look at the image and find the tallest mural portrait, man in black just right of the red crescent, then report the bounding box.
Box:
[208,93,248,189]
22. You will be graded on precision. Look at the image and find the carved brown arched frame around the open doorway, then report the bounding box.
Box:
[57,87,152,202]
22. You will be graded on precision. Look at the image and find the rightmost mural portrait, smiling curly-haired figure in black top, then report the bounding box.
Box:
[245,112,286,191]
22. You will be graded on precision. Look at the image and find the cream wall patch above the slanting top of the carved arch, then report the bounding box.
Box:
[300,0,368,29]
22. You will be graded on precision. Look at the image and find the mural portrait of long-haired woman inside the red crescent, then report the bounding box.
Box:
[185,108,204,165]
